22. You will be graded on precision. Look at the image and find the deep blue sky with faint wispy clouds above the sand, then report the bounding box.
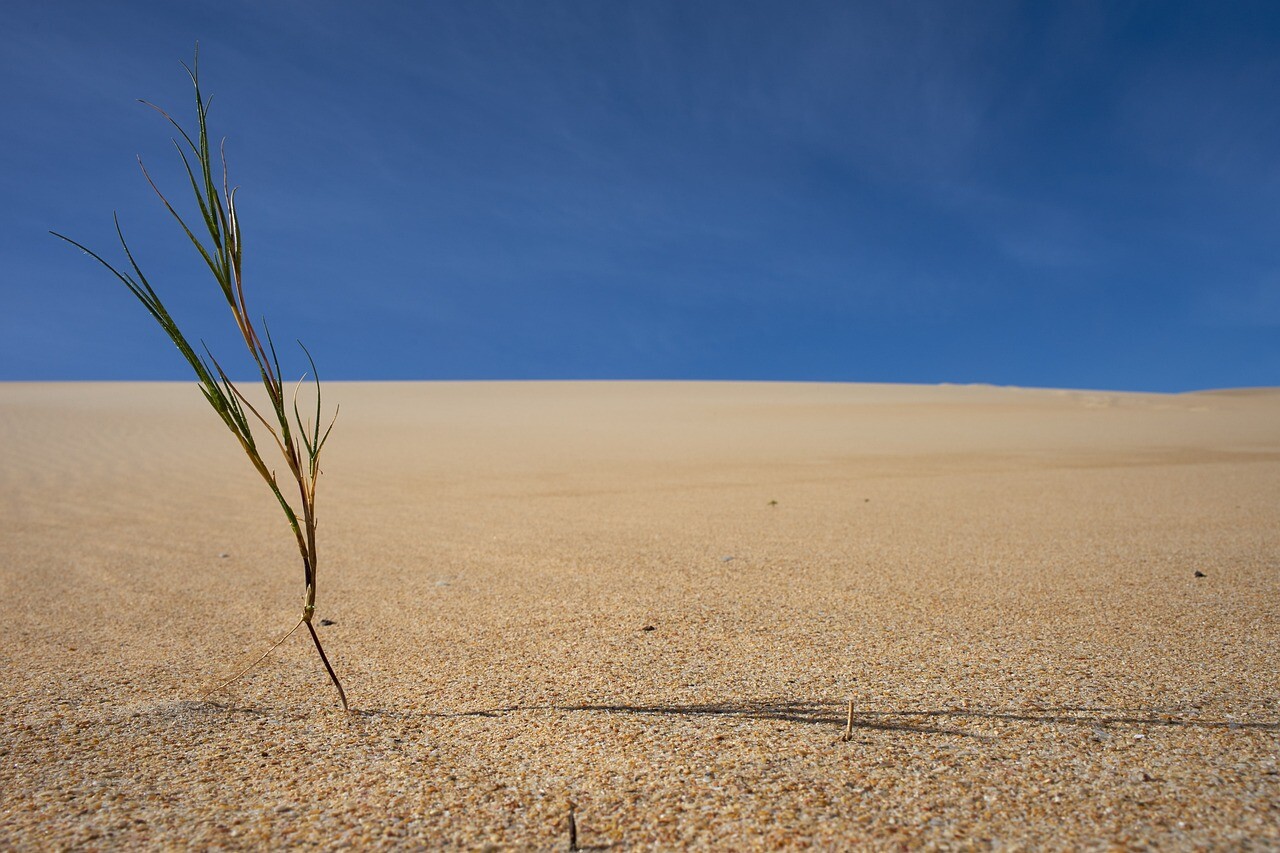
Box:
[0,0,1280,391]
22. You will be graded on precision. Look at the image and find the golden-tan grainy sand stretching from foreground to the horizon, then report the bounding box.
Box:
[0,383,1280,849]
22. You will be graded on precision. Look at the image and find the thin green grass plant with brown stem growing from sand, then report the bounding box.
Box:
[51,49,348,708]
